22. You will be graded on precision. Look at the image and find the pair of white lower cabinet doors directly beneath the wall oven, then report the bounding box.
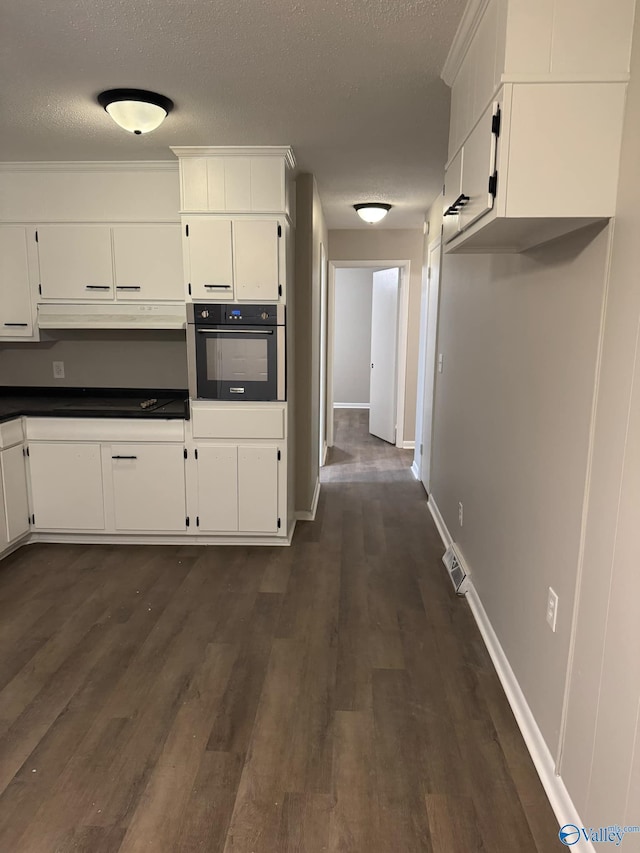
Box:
[197,444,281,533]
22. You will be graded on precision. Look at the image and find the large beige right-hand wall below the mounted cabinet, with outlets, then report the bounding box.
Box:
[433,3,640,824]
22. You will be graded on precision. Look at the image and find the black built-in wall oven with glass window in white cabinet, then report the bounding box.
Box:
[187,302,286,400]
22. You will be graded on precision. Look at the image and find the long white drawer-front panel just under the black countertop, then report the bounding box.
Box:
[26,418,184,441]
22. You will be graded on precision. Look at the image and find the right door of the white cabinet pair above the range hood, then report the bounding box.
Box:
[113,224,184,302]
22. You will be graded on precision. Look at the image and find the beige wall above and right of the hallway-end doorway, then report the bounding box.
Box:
[329,228,423,441]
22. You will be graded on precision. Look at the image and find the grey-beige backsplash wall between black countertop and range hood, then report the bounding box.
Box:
[0,330,187,388]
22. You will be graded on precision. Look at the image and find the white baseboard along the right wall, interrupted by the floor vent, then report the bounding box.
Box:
[428,496,595,853]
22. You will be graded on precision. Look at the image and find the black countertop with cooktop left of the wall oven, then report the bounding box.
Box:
[0,385,189,423]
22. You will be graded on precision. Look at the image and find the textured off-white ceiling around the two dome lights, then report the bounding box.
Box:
[0,0,465,228]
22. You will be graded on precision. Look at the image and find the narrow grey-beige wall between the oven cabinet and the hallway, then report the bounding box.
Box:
[293,174,328,512]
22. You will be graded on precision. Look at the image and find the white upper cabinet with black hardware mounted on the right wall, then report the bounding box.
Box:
[443,0,634,252]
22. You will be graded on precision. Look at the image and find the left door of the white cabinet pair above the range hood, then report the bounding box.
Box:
[38,225,113,301]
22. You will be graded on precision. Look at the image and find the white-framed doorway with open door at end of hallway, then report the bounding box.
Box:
[326,259,410,447]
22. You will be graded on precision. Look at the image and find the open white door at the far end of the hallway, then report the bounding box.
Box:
[369,267,400,444]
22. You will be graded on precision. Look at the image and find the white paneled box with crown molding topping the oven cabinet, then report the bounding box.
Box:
[172,147,294,213]
